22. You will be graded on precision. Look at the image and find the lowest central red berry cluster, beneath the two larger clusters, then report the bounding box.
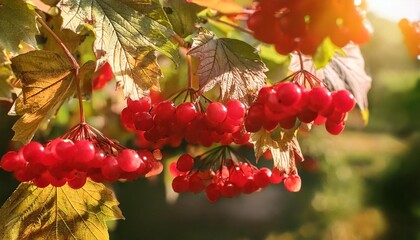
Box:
[171,154,301,202]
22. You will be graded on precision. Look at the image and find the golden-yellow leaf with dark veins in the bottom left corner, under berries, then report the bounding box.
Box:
[0,181,124,240]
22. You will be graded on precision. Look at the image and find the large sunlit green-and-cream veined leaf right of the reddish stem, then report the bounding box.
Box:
[57,0,179,99]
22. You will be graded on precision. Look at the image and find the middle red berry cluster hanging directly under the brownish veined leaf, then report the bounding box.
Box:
[121,97,249,147]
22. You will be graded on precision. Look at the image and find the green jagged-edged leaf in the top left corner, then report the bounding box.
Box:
[0,0,38,54]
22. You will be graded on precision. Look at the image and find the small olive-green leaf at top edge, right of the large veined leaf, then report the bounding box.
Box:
[162,0,203,37]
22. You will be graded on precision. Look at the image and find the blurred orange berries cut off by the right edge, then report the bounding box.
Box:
[398,18,420,58]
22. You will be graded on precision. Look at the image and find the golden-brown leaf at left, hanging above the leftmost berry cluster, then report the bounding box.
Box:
[9,50,76,143]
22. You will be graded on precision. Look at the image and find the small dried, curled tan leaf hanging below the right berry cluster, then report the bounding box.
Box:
[250,128,303,174]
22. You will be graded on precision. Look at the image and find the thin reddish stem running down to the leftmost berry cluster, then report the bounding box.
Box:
[36,15,85,123]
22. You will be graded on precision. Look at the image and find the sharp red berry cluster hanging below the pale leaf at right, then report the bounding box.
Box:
[245,82,356,135]
